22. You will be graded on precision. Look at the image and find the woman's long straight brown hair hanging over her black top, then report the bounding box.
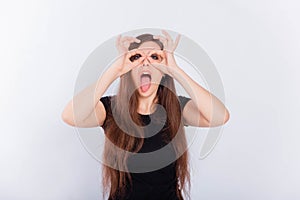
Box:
[102,34,190,200]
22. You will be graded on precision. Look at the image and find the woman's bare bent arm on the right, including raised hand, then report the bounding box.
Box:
[153,30,230,127]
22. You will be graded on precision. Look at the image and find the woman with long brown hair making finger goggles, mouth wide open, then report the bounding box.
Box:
[62,31,229,200]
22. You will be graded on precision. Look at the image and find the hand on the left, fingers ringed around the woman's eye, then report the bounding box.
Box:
[115,35,145,77]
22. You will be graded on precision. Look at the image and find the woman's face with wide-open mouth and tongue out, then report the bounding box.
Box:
[131,41,166,97]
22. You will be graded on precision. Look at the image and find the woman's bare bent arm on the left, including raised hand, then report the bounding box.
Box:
[61,36,139,127]
